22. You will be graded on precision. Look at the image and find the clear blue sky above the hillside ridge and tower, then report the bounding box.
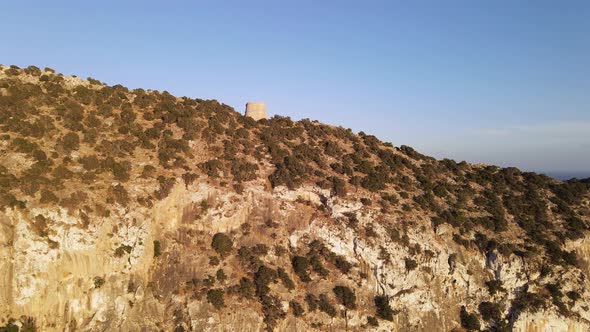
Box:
[0,0,590,171]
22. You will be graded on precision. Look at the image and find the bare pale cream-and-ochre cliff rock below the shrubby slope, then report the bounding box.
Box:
[0,183,589,331]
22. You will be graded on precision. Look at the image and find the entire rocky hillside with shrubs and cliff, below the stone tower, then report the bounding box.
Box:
[0,66,590,331]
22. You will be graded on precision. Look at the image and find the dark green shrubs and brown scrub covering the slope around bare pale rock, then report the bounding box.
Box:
[0,66,590,331]
